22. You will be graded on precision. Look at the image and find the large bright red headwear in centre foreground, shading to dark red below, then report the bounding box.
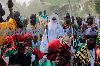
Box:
[47,39,62,61]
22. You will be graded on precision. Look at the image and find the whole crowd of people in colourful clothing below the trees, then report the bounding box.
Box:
[0,1,100,66]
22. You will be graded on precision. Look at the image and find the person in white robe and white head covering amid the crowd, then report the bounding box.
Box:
[40,14,64,53]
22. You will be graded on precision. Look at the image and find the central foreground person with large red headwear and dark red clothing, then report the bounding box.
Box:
[40,39,71,66]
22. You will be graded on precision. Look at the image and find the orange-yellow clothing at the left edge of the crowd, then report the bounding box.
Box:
[0,18,16,45]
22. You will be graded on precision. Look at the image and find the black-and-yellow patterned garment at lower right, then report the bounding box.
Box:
[76,45,90,65]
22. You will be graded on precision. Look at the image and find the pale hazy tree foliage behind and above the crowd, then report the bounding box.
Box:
[1,0,100,17]
